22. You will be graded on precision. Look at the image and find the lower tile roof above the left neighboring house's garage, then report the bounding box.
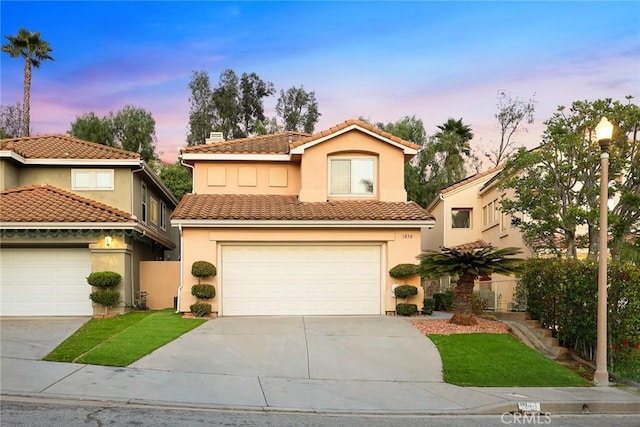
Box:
[0,184,137,223]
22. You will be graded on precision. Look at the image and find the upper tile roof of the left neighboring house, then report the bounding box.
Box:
[0,135,141,160]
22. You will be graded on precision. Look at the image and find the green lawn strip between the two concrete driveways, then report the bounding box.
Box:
[44,310,206,366]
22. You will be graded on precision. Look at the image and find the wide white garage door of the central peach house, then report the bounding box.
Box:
[220,245,381,316]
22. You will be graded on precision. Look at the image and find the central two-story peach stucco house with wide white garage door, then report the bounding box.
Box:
[171,120,434,316]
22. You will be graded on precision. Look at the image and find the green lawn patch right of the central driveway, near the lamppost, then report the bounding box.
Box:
[429,333,591,387]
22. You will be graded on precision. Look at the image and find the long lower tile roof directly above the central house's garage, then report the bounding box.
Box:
[171,194,433,221]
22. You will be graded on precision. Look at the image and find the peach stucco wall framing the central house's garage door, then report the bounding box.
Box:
[179,228,423,312]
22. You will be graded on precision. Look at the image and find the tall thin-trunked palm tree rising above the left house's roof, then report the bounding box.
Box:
[2,28,54,136]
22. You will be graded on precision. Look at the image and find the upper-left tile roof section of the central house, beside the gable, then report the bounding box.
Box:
[182,132,309,154]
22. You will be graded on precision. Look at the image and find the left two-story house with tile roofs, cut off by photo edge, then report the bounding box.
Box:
[0,135,178,316]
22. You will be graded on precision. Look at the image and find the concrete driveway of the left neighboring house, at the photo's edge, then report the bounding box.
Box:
[0,317,91,360]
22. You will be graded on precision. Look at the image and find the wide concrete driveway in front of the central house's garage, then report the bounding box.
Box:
[131,316,442,382]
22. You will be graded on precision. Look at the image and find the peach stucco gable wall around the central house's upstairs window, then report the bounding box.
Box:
[300,130,407,202]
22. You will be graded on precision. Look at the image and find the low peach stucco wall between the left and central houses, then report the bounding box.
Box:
[140,261,180,310]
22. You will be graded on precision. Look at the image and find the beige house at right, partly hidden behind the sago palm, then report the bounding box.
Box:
[422,165,534,310]
